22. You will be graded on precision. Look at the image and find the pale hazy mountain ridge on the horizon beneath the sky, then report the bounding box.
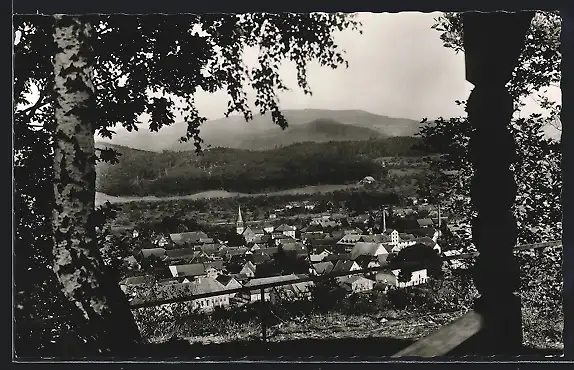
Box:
[97,109,420,152]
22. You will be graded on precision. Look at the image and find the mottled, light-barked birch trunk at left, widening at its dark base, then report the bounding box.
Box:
[52,15,139,355]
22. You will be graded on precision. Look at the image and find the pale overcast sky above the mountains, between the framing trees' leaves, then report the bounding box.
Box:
[196,12,472,120]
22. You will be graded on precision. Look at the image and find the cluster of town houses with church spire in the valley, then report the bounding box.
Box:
[121,202,468,311]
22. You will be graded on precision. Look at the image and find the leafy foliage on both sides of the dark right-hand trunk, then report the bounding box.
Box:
[420,12,562,244]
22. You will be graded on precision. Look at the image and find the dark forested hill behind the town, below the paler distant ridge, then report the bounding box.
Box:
[96,137,425,196]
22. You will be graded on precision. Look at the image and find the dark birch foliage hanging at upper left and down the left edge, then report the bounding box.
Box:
[13,13,360,355]
